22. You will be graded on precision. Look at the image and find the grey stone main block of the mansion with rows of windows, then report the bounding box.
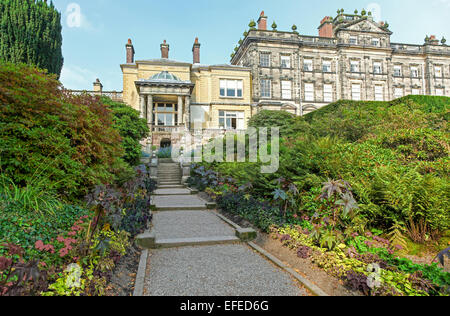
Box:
[231,11,450,115]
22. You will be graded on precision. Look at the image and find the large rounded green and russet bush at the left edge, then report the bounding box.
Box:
[0,63,132,199]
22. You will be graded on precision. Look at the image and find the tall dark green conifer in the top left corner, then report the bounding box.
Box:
[0,0,64,76]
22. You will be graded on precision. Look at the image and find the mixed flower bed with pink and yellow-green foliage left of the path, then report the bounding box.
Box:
[0,166,156,296]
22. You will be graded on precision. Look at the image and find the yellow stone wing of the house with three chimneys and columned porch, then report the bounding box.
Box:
[121,39,252,147]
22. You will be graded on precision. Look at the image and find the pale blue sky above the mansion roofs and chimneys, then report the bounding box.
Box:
[53,0,450,91]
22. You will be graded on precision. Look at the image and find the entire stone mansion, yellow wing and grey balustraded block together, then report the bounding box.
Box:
[117,11,450,147]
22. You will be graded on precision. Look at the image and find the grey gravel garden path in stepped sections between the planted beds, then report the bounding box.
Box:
[140,188,308,296]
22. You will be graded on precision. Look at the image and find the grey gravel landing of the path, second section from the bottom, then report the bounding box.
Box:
[153,211,235,239]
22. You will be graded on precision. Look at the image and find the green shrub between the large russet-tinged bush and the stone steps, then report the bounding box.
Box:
[102,97,150,166]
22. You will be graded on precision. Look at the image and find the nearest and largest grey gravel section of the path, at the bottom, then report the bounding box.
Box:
[144,244,308,296]
